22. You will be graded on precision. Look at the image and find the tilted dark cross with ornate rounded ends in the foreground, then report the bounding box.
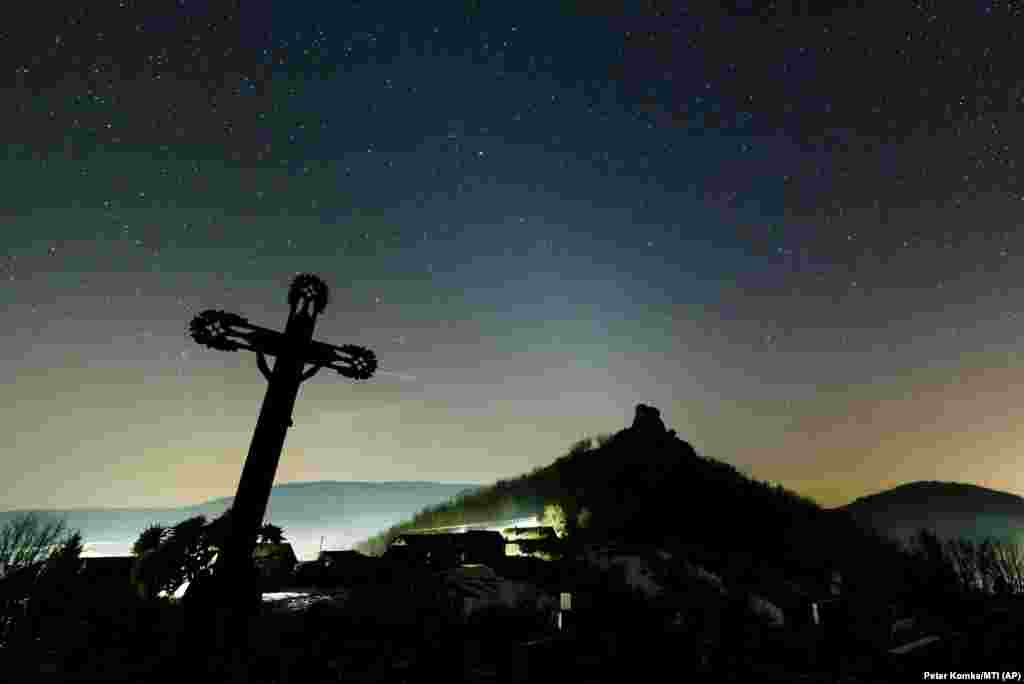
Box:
[189,273,377,618]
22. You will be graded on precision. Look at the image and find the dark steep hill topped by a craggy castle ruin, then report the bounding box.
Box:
[356,404,896,586]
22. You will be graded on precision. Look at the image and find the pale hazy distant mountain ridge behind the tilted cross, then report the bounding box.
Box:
[0,480,480,559]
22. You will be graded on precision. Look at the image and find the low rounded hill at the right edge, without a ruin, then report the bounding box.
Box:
[839,481,1024,544]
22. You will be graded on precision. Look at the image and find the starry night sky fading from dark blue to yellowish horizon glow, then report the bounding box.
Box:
[0,0,1024,509]
